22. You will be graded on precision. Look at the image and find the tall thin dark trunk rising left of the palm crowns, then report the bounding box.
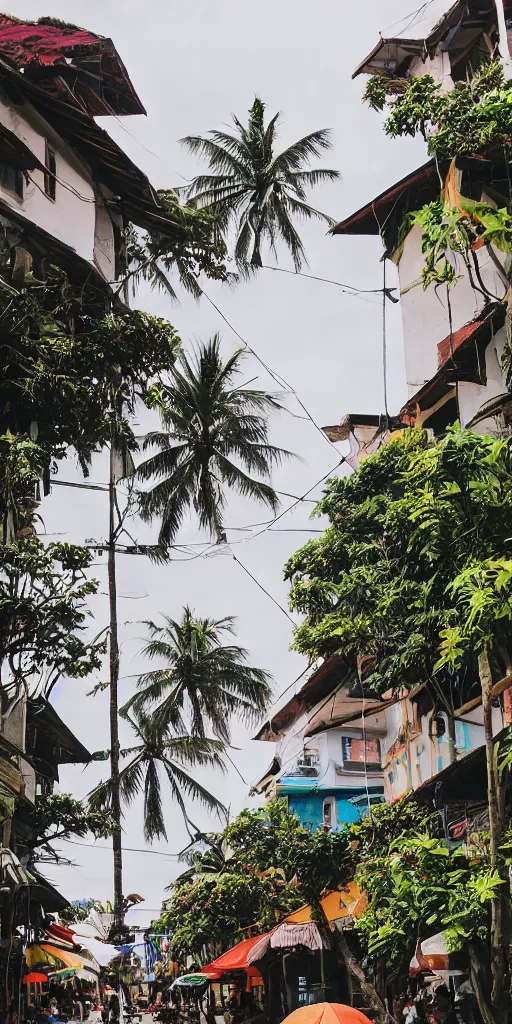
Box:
[109,419,123,928]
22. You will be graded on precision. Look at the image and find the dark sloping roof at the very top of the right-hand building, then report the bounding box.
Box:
[352,0,496,78]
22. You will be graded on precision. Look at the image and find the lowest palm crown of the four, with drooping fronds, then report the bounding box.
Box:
[89,712,226,843]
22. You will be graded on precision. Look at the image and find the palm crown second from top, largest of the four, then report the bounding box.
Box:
[137,334,291,548]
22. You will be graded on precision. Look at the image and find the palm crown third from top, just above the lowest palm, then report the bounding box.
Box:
[124,607,271,743]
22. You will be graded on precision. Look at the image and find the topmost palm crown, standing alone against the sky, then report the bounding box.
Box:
[181,98,340,270]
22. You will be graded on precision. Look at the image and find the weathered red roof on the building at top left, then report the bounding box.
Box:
[0,14,145,116]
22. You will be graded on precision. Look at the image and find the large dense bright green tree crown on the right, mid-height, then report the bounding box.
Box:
[285,419,512,700]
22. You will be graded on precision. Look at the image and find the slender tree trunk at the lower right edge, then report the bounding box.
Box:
[478,650,510,1022]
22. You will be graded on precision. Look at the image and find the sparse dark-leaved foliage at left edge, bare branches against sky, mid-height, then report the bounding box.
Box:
[0,537,104,700]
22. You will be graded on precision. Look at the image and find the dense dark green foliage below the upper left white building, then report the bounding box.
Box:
[0,268,179,468]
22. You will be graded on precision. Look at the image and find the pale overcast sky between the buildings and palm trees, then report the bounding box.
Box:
[9,0,449,925]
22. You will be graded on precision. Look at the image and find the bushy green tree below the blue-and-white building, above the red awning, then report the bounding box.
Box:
[151,800,353,958]
